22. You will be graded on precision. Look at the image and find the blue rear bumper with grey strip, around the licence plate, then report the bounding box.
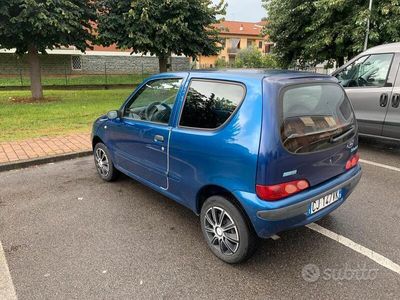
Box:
[234,165,362,238]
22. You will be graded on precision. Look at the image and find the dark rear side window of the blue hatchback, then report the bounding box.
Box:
[179,80,245,129]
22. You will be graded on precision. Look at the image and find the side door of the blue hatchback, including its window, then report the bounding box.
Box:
[103,77,183,188]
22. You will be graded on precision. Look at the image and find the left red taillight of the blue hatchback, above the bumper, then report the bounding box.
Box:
[256,180,310,201]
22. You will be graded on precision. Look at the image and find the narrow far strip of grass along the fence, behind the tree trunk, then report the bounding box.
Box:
[0,74,149,86]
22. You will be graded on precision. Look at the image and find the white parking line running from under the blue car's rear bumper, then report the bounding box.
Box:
[306,223,400,275]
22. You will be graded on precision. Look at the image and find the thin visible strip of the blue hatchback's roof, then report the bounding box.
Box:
[155,69,332,81]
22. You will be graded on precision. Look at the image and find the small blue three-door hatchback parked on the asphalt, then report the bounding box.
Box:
[92,70,361,263]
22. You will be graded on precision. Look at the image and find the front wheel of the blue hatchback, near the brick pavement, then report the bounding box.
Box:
[93,143,119,182]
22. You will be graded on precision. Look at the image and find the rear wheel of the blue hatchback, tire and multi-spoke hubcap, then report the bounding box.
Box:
[200,196,258,264]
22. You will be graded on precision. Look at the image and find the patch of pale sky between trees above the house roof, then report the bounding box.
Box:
[213,0,267,22]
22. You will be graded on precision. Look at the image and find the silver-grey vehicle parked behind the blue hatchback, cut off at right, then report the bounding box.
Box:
[332,43,400,141]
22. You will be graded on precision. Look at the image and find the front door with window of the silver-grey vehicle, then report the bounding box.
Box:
[334,53,397,135]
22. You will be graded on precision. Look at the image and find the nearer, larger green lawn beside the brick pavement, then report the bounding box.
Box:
[0,89,132,142]
